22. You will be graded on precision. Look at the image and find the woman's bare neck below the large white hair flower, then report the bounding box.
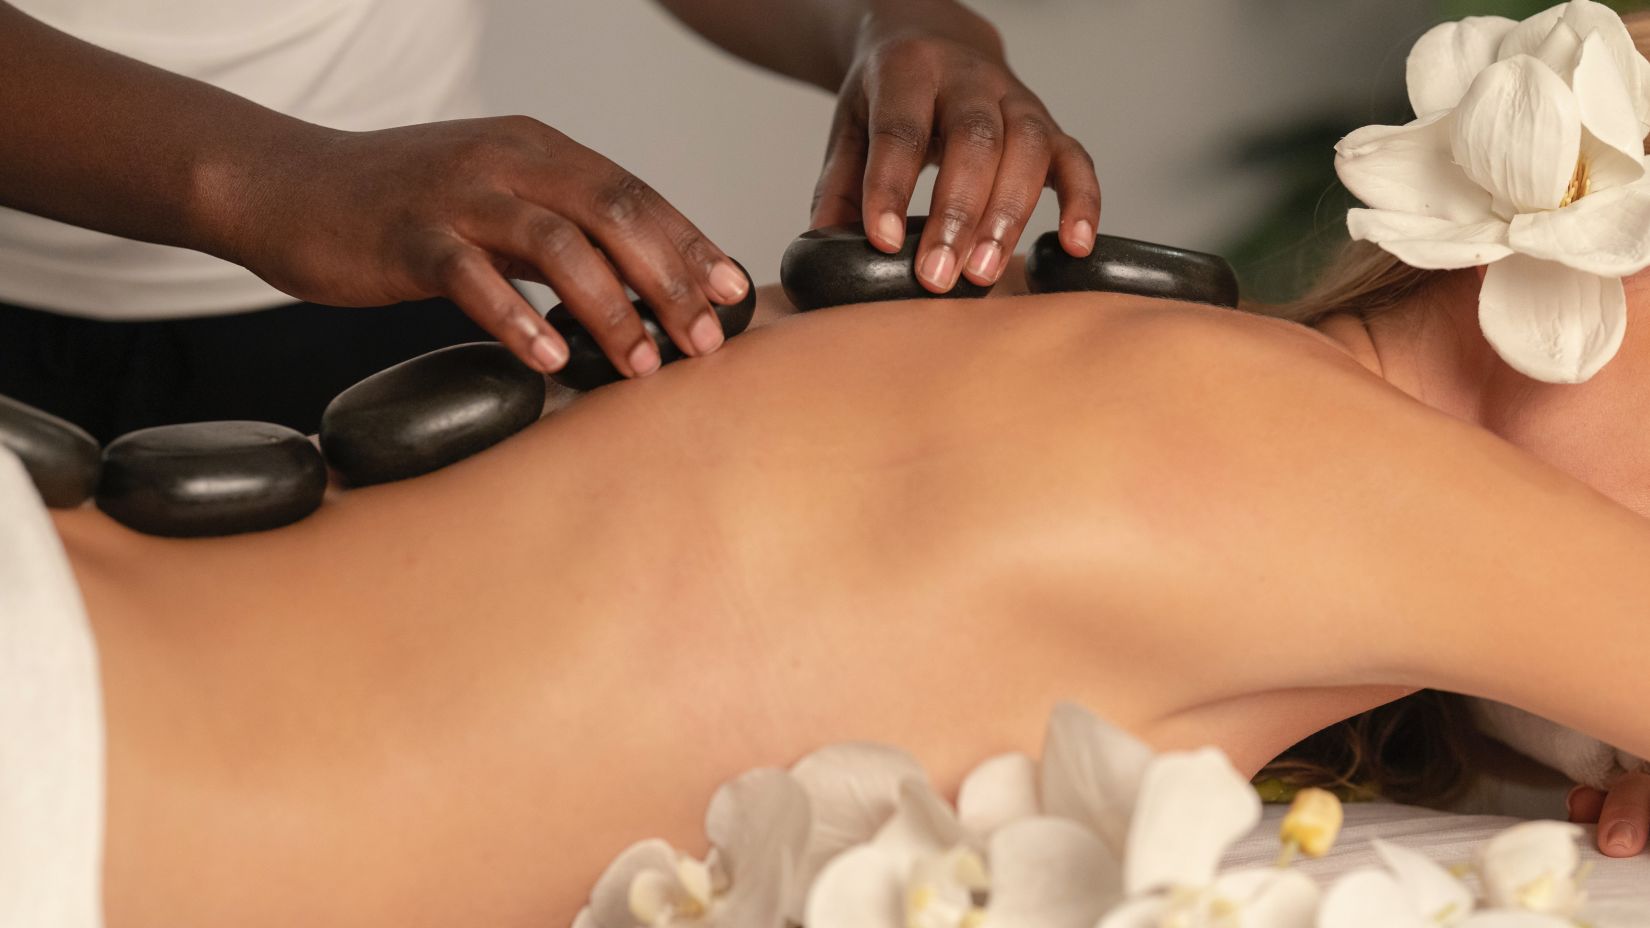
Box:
[1318,271,1650,515]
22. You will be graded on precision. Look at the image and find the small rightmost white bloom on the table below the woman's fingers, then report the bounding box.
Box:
[1478,822,1582,915]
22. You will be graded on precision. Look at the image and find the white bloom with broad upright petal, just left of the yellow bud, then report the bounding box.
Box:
[1099,748,1318,928]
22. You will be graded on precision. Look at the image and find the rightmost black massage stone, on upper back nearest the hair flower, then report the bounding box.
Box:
[1026,233,1238,309]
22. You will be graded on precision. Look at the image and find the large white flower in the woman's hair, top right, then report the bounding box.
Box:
[1335,0,1650,383]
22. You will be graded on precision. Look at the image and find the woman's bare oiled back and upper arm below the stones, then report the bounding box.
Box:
[58,285,1650,928]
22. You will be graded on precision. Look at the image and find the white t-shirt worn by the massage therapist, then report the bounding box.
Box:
[0,0,482,319]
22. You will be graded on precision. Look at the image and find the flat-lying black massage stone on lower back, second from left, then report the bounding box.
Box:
[97,423,327,538]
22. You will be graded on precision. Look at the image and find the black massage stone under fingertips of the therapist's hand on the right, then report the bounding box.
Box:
[779,216,992,310]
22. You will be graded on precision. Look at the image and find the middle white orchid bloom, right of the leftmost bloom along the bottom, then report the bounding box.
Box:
[804,771,1120,928]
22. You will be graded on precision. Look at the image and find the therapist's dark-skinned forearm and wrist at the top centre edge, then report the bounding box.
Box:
[658,0,1002,92]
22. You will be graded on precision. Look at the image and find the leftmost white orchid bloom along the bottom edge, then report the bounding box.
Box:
[576,769,810,928]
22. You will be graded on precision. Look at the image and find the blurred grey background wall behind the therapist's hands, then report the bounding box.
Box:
[483,0,1634,296]
